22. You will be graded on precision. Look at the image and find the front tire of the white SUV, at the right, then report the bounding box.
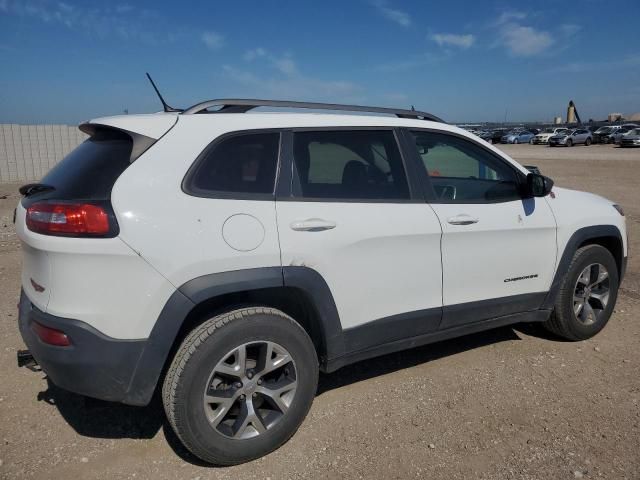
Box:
[543,245,619,341]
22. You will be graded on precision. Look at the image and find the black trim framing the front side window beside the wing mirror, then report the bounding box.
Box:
[402,127,527,205]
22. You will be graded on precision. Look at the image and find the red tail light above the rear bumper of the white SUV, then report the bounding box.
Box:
[26,202,116,237]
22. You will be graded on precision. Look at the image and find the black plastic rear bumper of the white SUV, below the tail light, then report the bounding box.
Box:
[19,292,147,403]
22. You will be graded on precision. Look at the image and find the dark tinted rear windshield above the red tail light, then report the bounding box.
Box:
[40,131,133,200]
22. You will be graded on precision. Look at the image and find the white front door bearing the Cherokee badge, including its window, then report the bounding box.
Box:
[411,130,556,328]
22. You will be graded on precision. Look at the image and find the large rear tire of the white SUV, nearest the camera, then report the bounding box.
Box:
[162,307,318,466]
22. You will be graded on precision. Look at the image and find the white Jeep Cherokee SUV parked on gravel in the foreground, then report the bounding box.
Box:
[16,100,627,465]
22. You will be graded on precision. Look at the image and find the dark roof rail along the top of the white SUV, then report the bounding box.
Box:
[182,98,445,123]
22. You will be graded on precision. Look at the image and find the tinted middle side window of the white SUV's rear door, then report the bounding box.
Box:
[294,130,409,200]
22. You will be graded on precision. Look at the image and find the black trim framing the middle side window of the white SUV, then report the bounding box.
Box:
[276,125,425,204]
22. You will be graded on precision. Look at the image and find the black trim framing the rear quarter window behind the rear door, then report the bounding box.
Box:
[185,128,283,201]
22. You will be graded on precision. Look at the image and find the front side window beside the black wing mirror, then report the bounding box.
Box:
[412,131,520,203]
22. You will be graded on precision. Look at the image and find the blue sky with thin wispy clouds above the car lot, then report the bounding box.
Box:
[0,0,640,124]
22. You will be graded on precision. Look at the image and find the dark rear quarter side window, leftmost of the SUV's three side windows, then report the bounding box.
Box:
[185,133,280,196]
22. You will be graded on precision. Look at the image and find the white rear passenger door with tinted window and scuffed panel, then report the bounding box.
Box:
[276,129,442,350]
